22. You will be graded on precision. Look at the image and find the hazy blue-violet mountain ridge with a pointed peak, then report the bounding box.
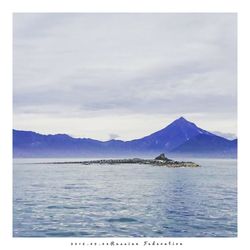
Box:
[13,117,237,157]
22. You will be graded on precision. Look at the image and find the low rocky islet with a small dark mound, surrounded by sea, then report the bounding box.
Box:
[44,154,200,168]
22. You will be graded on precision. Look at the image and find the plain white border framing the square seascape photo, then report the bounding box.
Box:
[0,0,250,250]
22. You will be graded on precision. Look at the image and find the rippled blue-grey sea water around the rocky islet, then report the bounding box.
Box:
[13,159,237,237]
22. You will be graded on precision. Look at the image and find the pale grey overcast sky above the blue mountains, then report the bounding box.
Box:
[13,14,237,140]
